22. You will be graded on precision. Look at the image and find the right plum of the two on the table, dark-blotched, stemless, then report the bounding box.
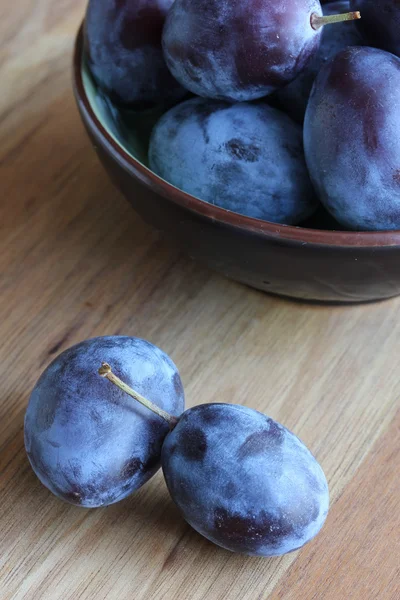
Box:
[162,404,329,556]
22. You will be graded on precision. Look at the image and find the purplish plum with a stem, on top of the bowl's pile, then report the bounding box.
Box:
[163,0,322,102]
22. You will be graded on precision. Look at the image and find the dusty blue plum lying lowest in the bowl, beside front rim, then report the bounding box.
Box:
[149,98,317,224]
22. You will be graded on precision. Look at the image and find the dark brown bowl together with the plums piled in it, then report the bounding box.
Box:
[74,0,400,303]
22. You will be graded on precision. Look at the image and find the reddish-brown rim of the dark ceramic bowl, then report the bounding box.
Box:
[73,20,400,248]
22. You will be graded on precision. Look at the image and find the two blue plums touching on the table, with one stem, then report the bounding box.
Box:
[25,336,329,556]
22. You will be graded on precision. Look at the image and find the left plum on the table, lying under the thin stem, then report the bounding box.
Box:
[25,336,184,507]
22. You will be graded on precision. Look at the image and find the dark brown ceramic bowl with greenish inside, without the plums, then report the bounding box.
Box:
[73,29,400,302]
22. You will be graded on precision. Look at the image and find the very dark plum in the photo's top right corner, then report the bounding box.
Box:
[350,0,400,56]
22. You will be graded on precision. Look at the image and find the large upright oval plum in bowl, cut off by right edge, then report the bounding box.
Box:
[304,47,400,230]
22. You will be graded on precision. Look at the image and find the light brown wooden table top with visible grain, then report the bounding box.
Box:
[0,0,400,600]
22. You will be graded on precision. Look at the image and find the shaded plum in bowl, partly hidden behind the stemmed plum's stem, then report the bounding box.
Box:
[275,0,364,123]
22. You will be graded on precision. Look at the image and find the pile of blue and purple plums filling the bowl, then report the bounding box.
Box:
[85,0,400,230]
